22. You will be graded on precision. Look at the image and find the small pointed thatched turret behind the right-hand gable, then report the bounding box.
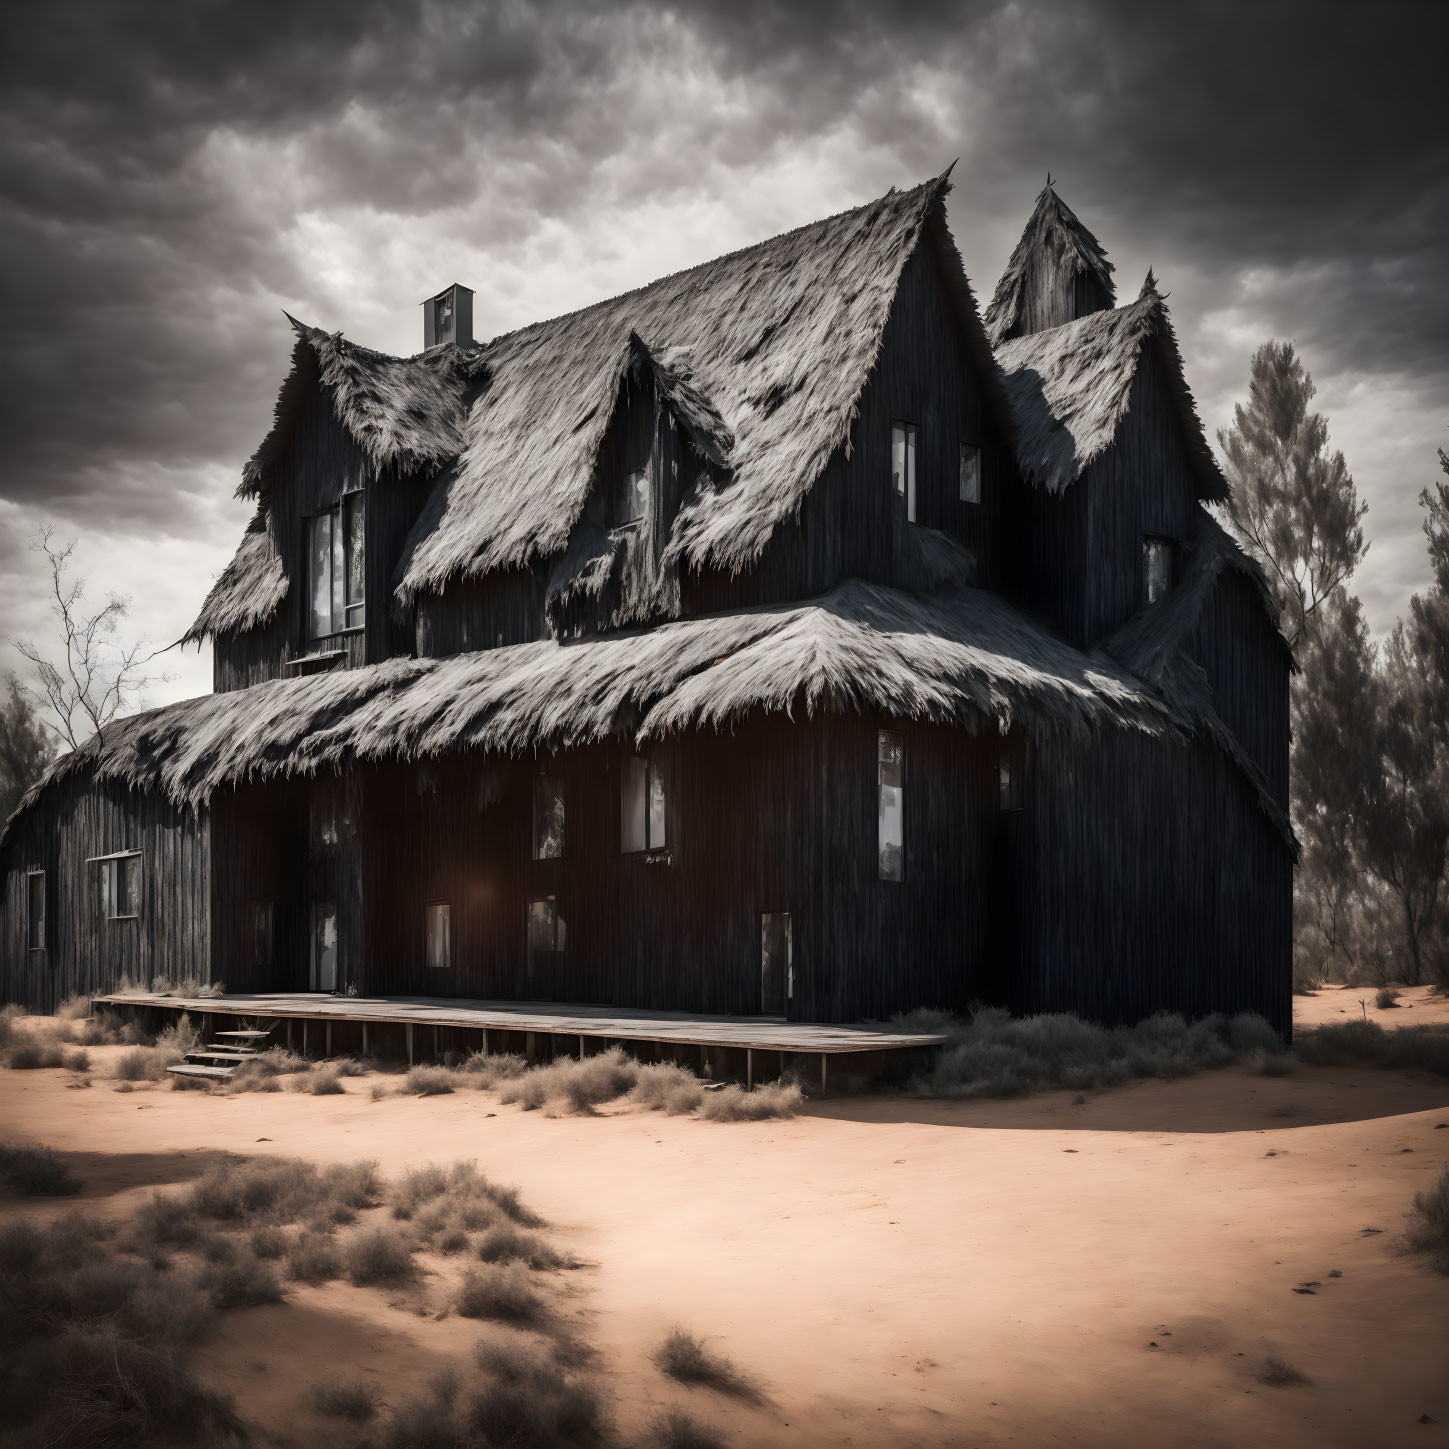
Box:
[985,175,1117,345]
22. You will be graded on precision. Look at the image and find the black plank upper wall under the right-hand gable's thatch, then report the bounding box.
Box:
[1004,347,1195,648]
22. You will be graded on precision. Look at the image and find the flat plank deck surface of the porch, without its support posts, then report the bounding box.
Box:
[93,991,945,1056]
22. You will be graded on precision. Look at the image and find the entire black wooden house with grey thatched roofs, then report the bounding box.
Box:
[0,177,1295,1032]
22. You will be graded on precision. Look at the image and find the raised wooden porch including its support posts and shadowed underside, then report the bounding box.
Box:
[93,993,945,1087]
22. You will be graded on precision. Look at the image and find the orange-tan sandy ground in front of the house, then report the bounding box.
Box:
[0,991,1449,1449]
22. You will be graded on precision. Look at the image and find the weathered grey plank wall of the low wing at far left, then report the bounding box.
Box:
[0,780,210,1011]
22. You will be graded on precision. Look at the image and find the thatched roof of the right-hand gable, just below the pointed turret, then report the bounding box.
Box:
[995,272,1227,501]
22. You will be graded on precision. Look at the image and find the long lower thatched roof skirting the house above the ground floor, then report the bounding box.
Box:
[11,581,1184,828]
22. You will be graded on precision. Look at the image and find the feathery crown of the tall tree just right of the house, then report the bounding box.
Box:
[1217,342,1368,653]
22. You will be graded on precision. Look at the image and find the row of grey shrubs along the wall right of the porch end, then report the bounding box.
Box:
[898,1007,1287,1097]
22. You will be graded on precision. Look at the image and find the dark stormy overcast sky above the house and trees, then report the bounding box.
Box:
[0,0,1449,703]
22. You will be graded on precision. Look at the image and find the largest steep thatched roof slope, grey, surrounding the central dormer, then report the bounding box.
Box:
[398,177,994,600]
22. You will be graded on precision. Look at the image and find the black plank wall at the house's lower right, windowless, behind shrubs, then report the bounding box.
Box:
[1003,733,1293,1035]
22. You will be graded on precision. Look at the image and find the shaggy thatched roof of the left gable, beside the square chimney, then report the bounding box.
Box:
[236,316,484,497]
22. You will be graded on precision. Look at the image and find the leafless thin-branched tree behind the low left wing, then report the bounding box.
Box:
[14,527,167,749]
